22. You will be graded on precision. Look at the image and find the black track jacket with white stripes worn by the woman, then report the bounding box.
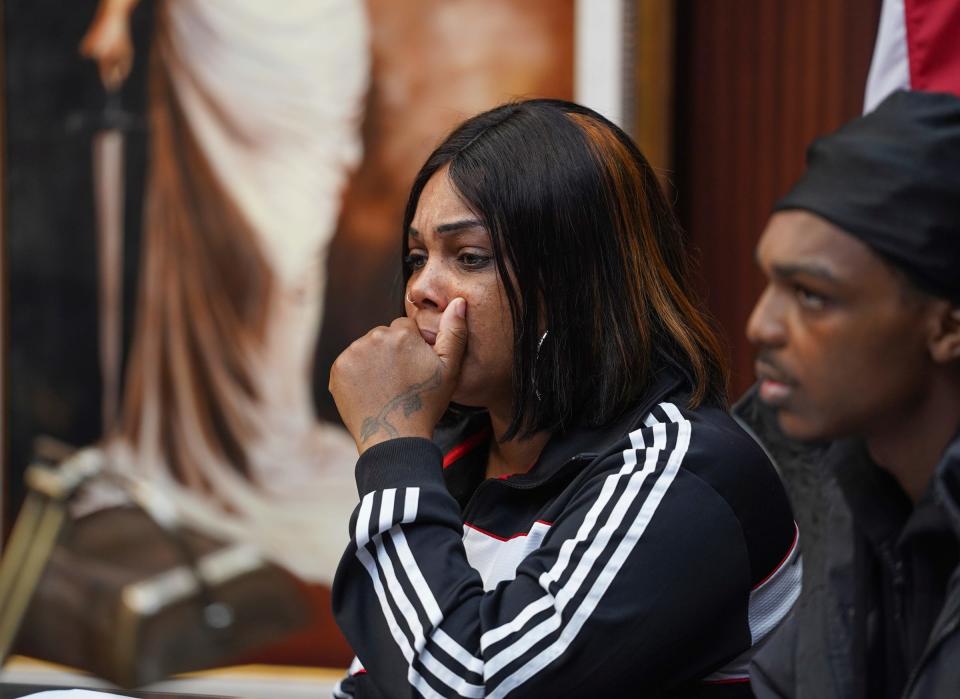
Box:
[333,376,801,698]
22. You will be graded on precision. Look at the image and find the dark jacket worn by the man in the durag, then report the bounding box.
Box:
[734,389,960,699]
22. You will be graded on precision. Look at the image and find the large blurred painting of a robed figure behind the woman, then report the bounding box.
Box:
[2,0,574,665]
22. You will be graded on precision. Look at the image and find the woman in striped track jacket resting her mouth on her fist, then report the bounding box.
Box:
[330,100,800,697]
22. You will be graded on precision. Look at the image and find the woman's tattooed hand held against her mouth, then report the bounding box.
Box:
[330,298,467,454]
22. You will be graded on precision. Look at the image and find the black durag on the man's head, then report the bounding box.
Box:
[774,91,960,302]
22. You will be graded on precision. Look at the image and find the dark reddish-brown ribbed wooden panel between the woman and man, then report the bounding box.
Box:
[675,0,880,396]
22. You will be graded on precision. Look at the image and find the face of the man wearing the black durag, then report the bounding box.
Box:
[747,211,931,440]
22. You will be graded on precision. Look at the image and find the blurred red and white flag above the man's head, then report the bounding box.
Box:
[863,0,960,113]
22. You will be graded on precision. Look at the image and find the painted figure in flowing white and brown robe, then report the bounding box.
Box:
[80,0,370,585]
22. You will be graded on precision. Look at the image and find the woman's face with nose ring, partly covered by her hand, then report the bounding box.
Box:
[404,168,513,419]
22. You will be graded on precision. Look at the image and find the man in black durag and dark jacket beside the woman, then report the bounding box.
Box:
[736,92,960,699]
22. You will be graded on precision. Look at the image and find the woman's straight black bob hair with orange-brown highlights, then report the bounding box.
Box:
[402,99,727,439]
